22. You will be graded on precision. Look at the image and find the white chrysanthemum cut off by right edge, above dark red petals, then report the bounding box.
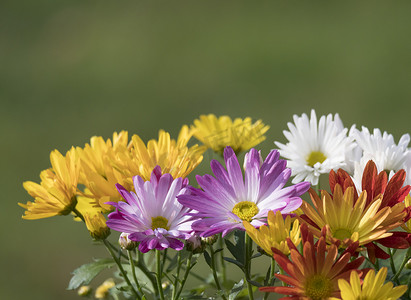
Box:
[350,126,411,187]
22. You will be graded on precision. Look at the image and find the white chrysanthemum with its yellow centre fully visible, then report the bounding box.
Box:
[275,110,354,185]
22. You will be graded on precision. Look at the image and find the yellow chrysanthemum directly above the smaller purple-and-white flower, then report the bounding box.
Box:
[115,125,206,180]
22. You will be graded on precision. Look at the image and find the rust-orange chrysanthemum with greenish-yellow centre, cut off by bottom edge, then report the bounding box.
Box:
[260,224,364,300]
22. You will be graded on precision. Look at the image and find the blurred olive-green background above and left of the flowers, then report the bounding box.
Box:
[0,0,411,300]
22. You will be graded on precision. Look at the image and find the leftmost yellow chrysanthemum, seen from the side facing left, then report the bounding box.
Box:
[19,148,79,220]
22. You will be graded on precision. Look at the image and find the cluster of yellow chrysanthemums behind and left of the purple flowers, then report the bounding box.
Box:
[19,114,268,239]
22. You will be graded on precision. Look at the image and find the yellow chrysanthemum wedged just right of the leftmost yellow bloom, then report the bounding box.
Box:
[76,131,132,212]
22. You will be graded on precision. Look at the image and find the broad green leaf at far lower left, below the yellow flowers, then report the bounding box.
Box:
[67,258,115,290]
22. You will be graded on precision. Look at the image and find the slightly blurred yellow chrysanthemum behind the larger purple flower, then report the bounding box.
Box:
[192,114,270,153]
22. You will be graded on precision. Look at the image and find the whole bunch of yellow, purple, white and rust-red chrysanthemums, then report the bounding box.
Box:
[19,111,411,300]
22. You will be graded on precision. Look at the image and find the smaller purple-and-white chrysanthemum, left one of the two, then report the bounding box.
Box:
[107,167,192,253]
